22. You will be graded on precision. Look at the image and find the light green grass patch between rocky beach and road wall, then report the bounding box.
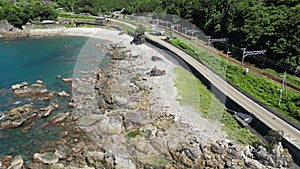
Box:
[174,67,259,145]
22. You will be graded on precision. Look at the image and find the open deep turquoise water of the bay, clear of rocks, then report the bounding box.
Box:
[0,37,88,88]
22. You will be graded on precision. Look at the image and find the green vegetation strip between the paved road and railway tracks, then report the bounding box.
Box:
[171,39,300,122]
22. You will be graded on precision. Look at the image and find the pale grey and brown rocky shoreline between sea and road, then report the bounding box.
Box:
[0,27,292,169]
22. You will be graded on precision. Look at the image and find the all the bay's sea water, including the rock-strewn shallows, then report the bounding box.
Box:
[0,37,104,163]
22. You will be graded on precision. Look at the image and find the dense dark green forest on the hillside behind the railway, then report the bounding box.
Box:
[0,0,300,68]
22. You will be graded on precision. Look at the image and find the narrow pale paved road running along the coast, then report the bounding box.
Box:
[110,20,300,150]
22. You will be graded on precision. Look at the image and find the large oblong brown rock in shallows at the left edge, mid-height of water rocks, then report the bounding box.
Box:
[1,104,37,129]
